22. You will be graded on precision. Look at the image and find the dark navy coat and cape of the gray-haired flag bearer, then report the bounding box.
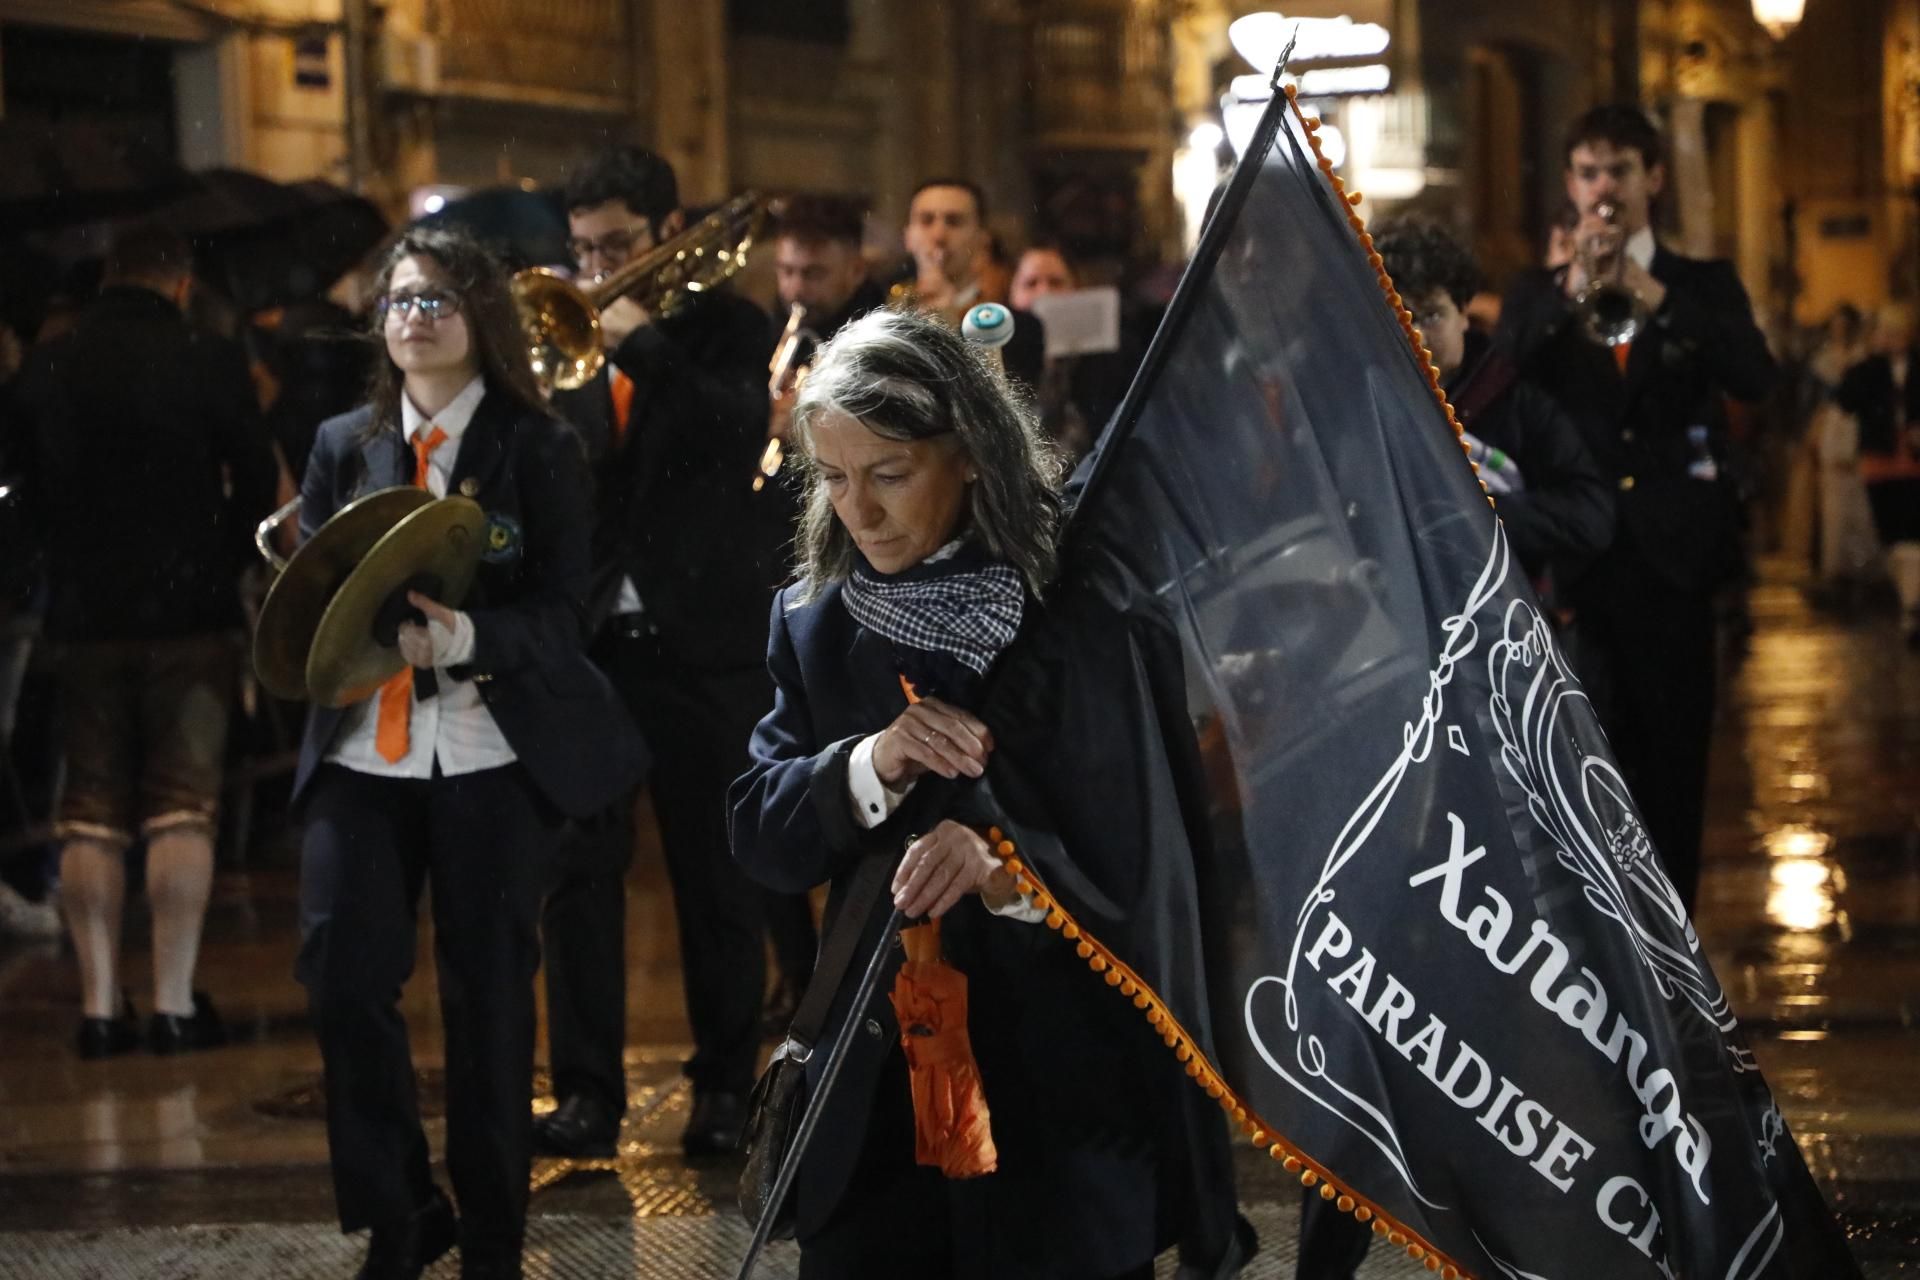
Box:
[728,585,1233,1274]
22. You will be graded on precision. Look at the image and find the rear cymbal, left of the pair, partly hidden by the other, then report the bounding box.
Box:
[253,486,434,702]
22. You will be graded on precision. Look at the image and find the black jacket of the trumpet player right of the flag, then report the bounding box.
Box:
[1500,246,1774,595]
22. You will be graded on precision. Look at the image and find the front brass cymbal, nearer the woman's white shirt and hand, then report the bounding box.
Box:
[307,497,486,706]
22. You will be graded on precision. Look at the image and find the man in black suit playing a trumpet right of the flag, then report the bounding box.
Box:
[1498,106,1774,910]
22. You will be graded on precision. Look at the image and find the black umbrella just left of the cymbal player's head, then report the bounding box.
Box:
[156,169,388,313]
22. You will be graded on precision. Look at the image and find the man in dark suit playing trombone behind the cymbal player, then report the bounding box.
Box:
[538,146,793,1155]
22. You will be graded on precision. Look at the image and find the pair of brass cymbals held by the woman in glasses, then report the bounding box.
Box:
[253,487,486,706]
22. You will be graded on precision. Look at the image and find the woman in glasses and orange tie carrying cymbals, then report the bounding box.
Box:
[294,230,641,1280]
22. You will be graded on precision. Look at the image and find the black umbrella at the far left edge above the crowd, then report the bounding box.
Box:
[0,119,194,234]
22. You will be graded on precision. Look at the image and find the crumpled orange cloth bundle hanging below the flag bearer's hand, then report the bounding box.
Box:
[891,921,1000,1178]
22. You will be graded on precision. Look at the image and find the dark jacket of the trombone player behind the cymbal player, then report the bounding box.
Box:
[553,290,795,670]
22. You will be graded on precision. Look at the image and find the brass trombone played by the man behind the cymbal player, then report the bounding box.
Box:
[513,192,766,391]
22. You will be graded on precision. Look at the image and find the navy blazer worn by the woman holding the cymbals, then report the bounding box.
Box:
[294,391,647,818]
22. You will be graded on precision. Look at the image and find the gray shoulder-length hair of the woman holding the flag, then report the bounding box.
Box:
[793,309,1062,601]
